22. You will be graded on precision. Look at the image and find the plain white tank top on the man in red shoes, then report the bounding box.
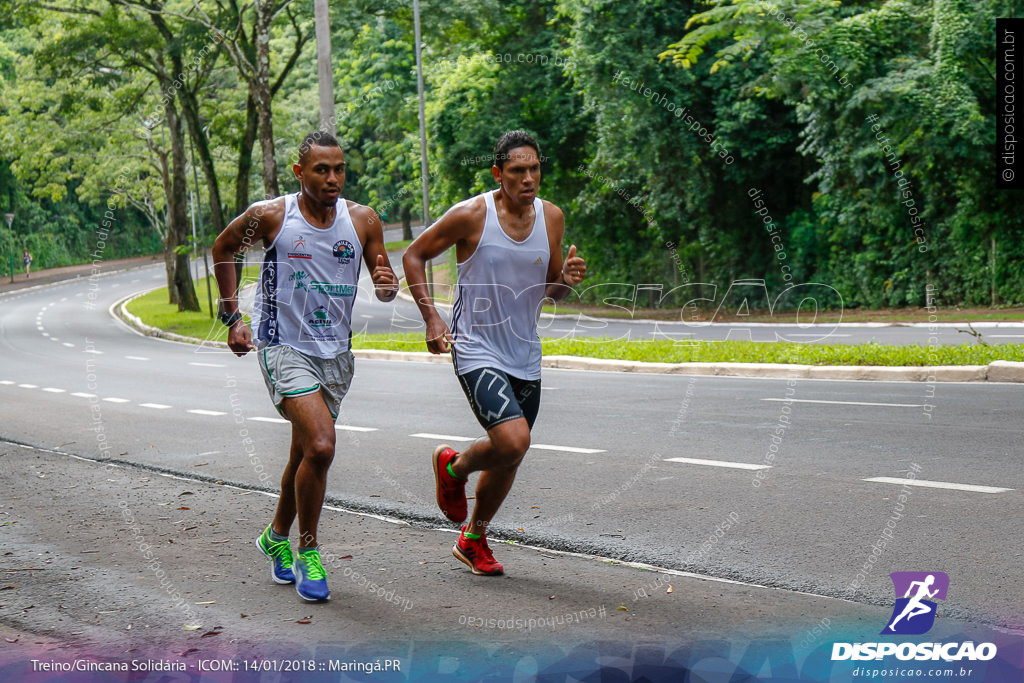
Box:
[452,191,551,380]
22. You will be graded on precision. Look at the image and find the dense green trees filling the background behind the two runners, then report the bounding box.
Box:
[0,0,1024,307]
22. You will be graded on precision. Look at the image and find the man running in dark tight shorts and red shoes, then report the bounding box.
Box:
[403,130,587,575]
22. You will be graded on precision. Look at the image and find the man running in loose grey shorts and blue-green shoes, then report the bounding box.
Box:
[213,132,398,602]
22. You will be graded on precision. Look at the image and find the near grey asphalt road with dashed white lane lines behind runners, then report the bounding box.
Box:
[0,268,1024,683]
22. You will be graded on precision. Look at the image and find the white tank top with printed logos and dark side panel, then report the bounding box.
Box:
[252,194,362,358]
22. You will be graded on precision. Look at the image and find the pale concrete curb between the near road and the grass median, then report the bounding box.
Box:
[110,288,1024,383]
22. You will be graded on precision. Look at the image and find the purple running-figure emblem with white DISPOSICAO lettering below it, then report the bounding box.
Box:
[831,571,996,661]
